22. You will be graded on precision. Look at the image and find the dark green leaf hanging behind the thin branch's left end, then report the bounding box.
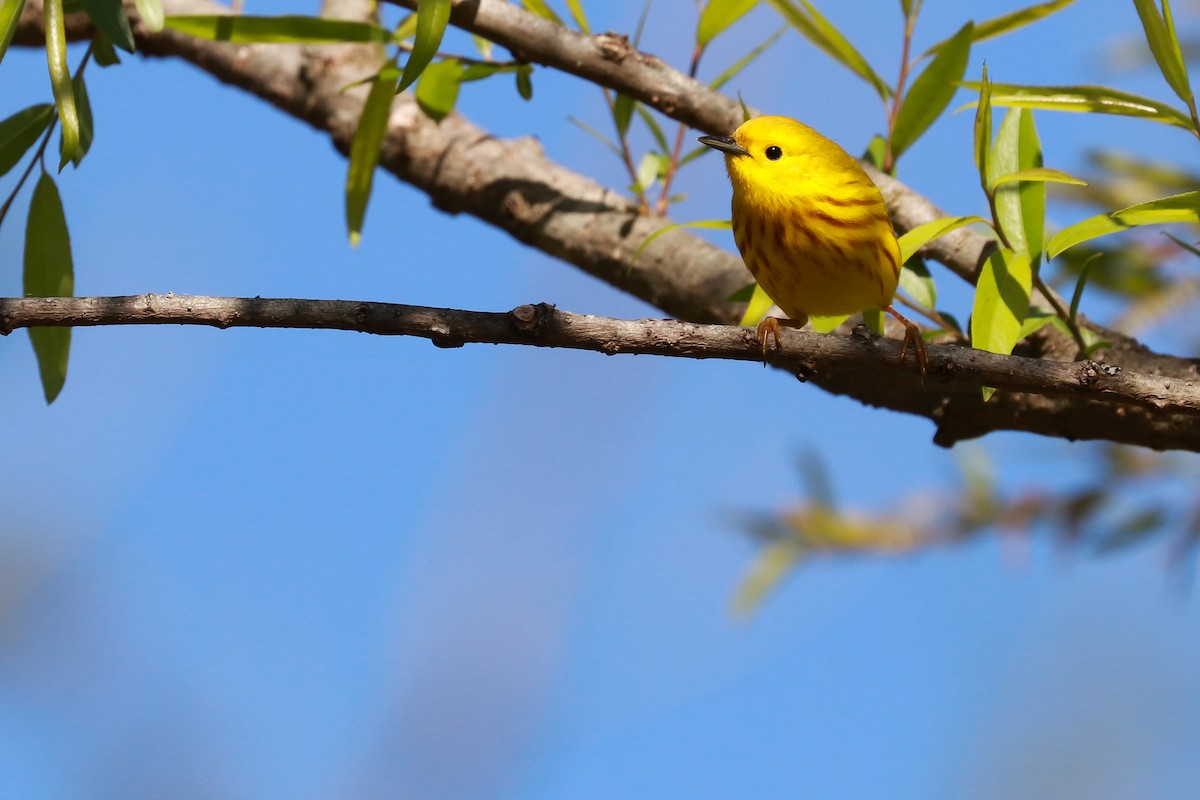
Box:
[24,172,74,403]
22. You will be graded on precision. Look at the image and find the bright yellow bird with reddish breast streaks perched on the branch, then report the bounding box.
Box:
[700,116,925,373]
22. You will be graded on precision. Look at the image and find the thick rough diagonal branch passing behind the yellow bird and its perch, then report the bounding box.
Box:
[9,0,1196,449]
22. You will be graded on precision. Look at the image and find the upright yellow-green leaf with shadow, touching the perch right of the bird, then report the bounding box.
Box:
[971,247,1033,399]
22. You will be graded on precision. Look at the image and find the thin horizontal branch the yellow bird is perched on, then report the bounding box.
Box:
[7,294,1200,451]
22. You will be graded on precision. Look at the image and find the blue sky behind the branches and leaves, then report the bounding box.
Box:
[0,0,1200,800]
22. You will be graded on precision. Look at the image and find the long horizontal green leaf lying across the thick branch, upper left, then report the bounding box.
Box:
[166,14,392,44]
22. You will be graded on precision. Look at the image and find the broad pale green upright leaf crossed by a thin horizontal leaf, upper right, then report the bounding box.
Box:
[988,108,1046,264]
